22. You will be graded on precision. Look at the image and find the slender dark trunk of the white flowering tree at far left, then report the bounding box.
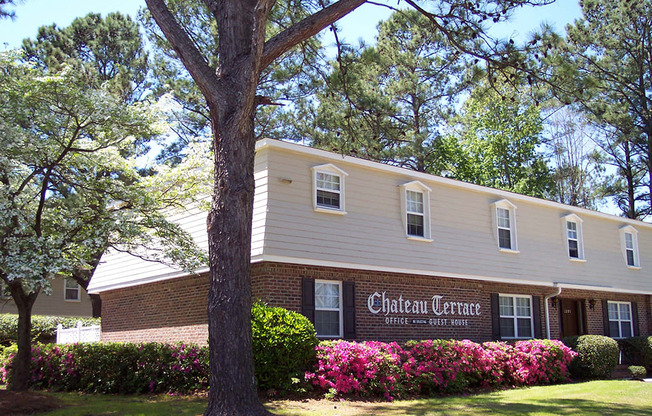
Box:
[9,282,38,391]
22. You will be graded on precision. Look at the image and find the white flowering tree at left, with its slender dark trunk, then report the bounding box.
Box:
[0,53,204,390]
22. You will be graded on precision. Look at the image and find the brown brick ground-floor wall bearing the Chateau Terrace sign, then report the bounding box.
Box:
[102,263,652,344]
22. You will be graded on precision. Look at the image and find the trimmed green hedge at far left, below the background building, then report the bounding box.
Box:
[0,314,101,346]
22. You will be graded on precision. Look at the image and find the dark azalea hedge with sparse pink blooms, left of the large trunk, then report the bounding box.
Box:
[0,343,208,394]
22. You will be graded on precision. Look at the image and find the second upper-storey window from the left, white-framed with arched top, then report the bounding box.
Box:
[399,181,432,242]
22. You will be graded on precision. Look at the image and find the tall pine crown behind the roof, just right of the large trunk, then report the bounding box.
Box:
[294,10,475,174]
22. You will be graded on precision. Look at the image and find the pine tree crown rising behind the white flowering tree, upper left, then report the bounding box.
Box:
[23,13,149,101]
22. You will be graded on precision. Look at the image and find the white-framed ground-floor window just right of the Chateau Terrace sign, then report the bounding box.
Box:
[498,295,534,339]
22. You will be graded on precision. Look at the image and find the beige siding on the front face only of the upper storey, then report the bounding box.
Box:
[264,147,652,291]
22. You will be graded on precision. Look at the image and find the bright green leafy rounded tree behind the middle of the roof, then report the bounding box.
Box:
[447,83,552,198]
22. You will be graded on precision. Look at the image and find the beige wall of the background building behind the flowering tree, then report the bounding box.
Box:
[0,276,93,317]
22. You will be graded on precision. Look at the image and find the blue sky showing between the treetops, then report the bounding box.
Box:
[0,0,580,50]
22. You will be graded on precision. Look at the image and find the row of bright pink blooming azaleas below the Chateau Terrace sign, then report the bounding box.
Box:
[306,340,576,400]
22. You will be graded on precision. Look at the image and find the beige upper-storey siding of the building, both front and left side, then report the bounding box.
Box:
[90,140,652,293]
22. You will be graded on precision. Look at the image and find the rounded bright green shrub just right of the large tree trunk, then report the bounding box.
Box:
[251,302,319,390]
